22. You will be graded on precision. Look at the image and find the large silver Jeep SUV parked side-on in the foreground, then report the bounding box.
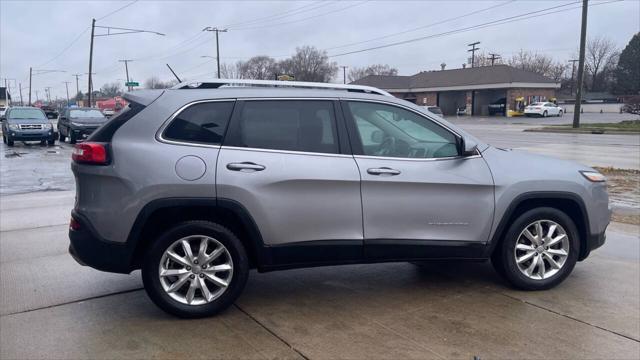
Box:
[69,80,610,317]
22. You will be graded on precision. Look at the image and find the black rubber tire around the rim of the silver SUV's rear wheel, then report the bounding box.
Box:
[142,221,249,318]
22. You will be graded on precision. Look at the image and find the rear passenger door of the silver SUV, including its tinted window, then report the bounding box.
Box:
[216,99,363,264]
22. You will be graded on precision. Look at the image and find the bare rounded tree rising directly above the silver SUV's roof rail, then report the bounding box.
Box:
[277,46,338,82]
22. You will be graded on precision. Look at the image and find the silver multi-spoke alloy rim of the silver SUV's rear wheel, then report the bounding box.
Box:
[158,235,233,305]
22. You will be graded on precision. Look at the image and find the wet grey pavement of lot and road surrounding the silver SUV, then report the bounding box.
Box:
[0,112,640,359]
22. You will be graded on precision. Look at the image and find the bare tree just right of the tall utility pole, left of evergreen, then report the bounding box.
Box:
[585,37,620,91]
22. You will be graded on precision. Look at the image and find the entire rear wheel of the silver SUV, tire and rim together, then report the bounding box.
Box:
[142,221,249,318]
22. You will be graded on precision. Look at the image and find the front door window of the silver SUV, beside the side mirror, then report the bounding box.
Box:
[348,101,458,158]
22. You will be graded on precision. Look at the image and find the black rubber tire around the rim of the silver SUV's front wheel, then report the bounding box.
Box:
[500,208,580,290]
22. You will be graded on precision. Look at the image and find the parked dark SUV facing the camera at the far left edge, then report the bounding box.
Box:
[0,106,55,146]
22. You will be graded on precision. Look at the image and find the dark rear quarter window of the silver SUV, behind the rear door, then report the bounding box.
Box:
[164,102,234,144]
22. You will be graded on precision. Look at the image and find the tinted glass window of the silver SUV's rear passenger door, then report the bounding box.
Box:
[234,100,338,153]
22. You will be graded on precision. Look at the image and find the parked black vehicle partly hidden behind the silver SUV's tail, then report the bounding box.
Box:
[58,107,107,144]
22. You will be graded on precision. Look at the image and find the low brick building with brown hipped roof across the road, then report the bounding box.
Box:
[352,65,560,115]
